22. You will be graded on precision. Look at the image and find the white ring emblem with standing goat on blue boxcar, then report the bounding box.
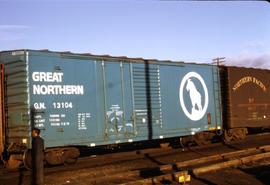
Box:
[179,72,209,121]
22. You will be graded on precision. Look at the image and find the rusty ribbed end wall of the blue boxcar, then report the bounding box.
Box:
[0,51,30,146]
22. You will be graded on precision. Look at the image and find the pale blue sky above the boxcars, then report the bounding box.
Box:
[0,0,270,68]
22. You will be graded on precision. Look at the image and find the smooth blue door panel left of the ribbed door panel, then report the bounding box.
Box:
[102,61,134,142]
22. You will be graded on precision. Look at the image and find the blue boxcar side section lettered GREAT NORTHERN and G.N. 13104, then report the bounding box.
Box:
[29,53,101,147]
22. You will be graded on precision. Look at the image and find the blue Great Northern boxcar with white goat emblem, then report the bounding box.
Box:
[0,50,222,168]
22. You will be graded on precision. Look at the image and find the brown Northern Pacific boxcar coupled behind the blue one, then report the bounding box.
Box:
[220,67,270,141]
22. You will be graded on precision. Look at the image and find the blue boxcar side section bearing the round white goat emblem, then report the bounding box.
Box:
[160,64,222,136]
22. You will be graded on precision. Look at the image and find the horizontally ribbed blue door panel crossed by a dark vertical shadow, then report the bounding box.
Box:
[133,64,162,126]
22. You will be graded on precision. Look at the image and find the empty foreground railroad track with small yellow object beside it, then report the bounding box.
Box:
[88,145,270,185]
